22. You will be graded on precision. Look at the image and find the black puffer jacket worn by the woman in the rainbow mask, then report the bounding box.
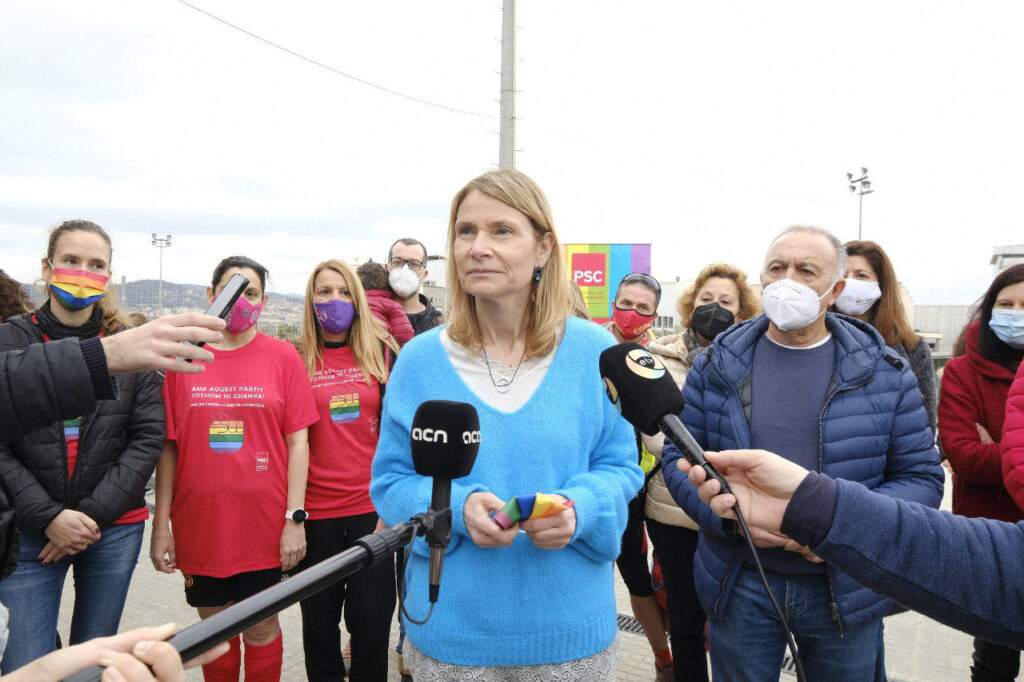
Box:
[0,315,165,534]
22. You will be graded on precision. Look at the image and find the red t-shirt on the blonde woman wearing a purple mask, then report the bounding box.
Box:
[306,346,381,519]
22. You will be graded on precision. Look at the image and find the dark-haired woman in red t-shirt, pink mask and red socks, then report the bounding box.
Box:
[150,256,318,682]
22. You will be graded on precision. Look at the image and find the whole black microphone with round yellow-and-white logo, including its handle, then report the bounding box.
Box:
[600,343,732,493]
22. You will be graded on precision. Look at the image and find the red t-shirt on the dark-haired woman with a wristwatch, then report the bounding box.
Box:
[164,333,318,578]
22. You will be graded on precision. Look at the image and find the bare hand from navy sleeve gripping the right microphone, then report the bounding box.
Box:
[676,450,808,534]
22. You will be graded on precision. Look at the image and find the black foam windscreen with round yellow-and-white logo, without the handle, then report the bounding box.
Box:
[600,343,683,435]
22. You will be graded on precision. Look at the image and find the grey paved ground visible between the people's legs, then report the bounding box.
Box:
[49,476,991,682]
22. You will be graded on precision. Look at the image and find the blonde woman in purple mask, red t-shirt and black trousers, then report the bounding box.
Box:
[300,260,398,682]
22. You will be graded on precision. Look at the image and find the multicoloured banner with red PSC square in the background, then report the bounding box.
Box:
[564,244,650,322]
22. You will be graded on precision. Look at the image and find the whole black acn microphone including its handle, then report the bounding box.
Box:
[411,400,480,603]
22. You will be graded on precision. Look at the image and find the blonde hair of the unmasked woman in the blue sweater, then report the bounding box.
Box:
[447,169,571,357]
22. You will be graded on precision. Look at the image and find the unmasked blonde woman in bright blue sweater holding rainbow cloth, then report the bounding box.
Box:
[370,170,642,681]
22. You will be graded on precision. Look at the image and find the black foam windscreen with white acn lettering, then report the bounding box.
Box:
[411,400,480,479]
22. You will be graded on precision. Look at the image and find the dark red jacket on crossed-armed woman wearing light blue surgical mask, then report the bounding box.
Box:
[939,322,1024,522]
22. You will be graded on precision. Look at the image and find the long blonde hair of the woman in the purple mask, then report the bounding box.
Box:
[299,258,398,378]
